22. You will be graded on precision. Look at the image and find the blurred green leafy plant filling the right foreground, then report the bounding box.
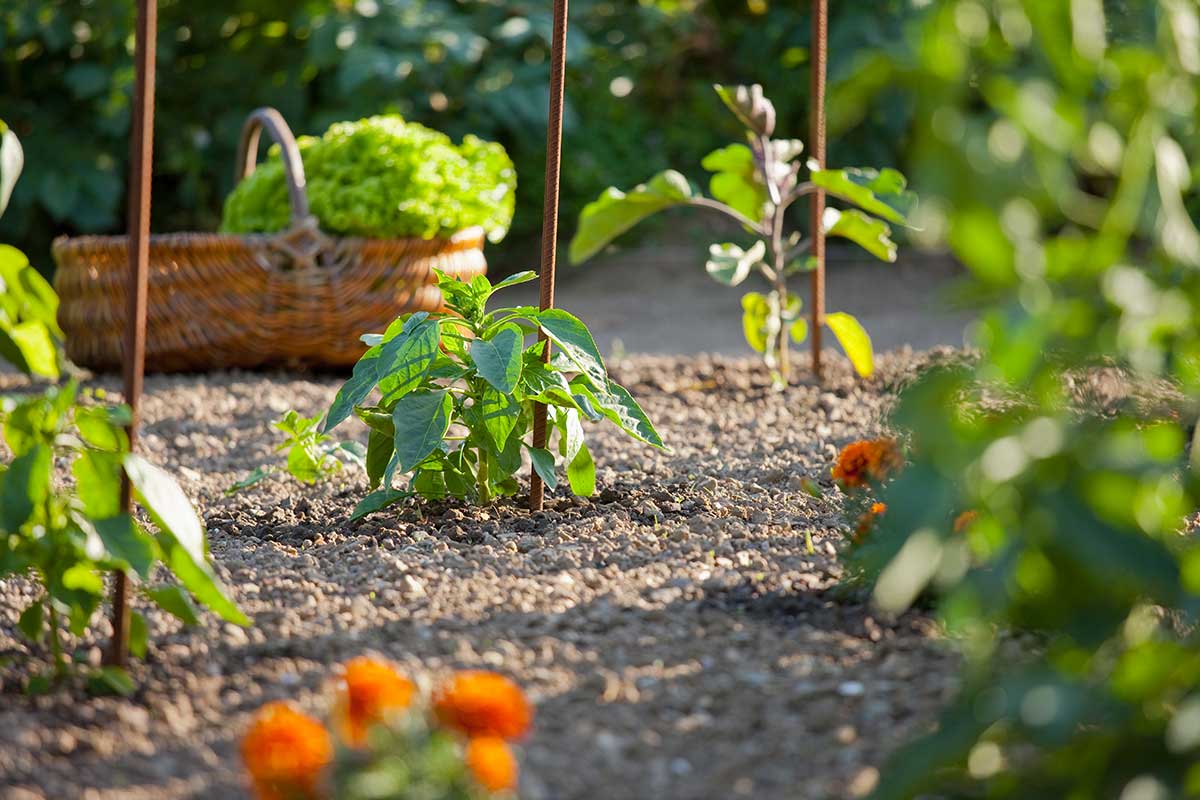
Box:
[847,0,1200,799]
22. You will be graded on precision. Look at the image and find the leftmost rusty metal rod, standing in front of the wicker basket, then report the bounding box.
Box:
[106,0,158,667]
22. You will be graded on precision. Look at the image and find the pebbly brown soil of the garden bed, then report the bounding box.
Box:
[0,353,958,800]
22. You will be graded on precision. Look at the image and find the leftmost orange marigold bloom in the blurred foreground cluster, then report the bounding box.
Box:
[241,703,334,800]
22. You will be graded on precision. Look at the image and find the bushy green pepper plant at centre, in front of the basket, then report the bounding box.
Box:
[323,272,664,518]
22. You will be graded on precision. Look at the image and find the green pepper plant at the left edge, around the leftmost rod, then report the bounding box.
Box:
[0,123,248,692]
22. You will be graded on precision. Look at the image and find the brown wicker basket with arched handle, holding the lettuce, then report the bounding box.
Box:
[54,108,486,372]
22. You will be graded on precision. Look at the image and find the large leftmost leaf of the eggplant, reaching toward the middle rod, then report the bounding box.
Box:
[569,169,695,264]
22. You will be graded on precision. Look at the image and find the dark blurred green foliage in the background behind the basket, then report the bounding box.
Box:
[0,0,910,272]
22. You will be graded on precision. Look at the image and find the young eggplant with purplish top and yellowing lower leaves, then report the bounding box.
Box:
[570,84,916,381]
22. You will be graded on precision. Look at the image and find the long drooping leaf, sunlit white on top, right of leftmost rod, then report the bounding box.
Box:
[125,453,250,625]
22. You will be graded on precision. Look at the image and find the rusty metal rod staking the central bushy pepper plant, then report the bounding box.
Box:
[529,0,566,511]
